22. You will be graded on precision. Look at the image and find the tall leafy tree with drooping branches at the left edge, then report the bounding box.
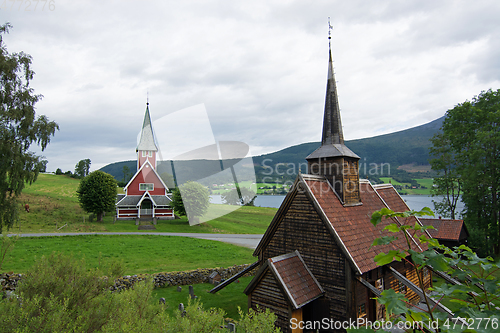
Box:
[0,23,59,231]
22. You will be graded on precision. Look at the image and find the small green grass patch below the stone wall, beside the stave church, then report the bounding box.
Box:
[153,276,253,320]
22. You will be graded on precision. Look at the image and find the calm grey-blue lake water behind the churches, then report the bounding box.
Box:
[210,195,464,218]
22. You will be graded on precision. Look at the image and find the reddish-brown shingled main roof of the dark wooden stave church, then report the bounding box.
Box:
[254,174,423,274]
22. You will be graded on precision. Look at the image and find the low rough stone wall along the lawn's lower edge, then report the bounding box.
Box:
[0,264,258,292]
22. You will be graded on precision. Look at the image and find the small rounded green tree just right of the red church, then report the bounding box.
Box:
[174,181,210,225]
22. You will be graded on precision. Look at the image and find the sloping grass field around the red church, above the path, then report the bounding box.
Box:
[11,174,277,234]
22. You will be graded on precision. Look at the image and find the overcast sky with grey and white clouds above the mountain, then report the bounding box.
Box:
[0,0,500,171]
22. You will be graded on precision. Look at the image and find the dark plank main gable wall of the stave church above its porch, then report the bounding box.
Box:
[263,191,348,321]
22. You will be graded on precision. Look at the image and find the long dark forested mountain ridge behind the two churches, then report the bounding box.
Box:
[101,116,444,186]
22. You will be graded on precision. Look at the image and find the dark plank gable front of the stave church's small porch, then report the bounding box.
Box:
[250,271,291,332]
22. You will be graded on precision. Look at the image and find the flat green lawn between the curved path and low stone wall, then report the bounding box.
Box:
[2,235,255,274]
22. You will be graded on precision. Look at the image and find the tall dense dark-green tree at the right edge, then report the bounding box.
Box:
[432,89,500,254]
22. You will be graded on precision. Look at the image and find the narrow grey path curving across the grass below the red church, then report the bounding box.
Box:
[9,232,263,249]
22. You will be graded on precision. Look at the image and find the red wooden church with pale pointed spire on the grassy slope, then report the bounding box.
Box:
[116,103,174,224]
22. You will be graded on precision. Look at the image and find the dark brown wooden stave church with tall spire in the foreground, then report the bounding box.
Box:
[245,41,432,332]
